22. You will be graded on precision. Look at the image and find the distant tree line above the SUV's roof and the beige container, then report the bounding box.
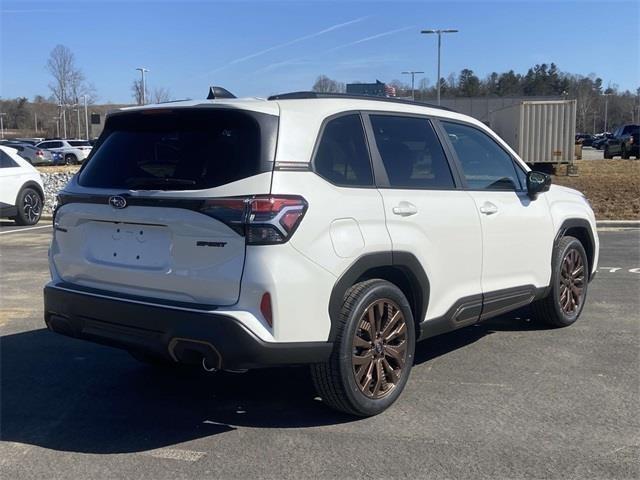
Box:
[312,63,640,133]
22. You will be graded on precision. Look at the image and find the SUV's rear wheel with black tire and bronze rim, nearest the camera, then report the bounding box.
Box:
[311,279,416,417]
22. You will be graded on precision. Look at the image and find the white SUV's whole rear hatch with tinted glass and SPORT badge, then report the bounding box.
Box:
[51,105,278,306]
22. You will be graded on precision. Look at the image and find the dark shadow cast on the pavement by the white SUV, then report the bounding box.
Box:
[0,312,548,453]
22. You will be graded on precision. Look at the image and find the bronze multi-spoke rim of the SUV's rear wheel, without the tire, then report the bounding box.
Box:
[351,298,407,400]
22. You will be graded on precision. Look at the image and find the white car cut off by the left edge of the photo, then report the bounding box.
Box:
[0,146,44,225]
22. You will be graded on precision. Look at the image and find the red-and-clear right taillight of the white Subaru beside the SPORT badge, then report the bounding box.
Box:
[200,195,307,245]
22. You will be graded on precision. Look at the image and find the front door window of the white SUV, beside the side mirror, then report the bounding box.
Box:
[441,121,523,190]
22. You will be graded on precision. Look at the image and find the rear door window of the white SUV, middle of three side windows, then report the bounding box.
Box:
[369,115,454,188]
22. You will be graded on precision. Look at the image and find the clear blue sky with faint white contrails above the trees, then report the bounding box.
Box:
[0,0,640,103]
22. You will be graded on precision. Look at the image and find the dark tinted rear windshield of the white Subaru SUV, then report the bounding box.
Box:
[78,107,277,190]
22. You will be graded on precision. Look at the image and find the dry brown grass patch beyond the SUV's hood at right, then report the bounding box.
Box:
[553,160,640,220]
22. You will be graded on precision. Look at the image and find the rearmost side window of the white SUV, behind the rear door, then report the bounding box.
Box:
[314,113,373,187]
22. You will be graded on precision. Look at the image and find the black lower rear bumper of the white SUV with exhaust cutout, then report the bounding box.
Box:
[44,284,332,370]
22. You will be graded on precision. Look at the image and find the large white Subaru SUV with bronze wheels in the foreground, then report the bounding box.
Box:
[44,92,599,416]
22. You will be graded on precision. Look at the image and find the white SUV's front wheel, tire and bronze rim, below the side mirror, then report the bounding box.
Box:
[531,236,589,327]
